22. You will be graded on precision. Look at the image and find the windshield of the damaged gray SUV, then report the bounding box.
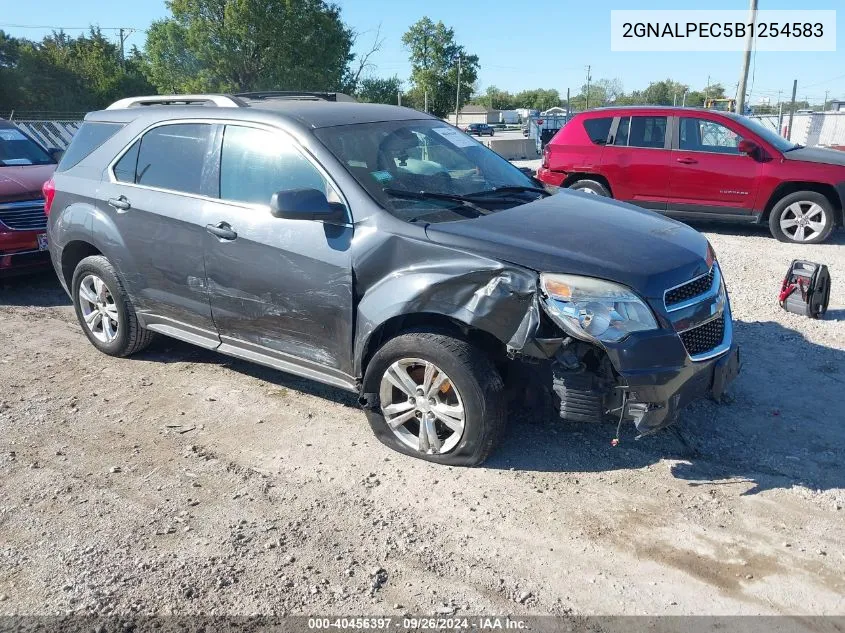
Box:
[315,119,548,222]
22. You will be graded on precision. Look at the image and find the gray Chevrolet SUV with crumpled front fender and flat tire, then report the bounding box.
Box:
[44,93,739,465]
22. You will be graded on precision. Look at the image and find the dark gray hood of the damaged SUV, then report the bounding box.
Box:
[426,191,708,298]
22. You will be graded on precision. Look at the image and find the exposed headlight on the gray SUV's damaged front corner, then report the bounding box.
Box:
[540,273,657,343]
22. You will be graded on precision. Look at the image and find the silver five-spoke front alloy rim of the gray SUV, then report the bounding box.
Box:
[379,358,466,455]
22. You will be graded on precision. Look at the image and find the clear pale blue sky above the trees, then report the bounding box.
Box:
[0,0,845,103]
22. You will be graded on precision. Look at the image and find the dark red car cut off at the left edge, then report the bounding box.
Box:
[0,119,58,276]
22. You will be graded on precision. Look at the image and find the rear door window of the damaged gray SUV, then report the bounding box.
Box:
[135,123,216,195]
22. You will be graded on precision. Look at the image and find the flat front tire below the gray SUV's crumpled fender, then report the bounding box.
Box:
[364,332,507,466]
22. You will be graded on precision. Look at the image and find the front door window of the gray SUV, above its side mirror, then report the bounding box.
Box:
[220,125,340,205]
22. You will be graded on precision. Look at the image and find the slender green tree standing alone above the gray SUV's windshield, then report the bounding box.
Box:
[402,17,478,117]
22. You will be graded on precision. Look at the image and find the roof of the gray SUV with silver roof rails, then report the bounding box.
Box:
[85,99,434,129]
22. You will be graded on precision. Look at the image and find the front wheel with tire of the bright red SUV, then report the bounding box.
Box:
[769,191,836,244]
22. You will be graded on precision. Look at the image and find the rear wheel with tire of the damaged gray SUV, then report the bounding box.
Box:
[71,255,155,357]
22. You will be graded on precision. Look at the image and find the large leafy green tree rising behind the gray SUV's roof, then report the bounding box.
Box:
[147,0,354,92]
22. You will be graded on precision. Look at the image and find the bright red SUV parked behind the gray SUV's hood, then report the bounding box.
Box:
[537,106,845,244]
